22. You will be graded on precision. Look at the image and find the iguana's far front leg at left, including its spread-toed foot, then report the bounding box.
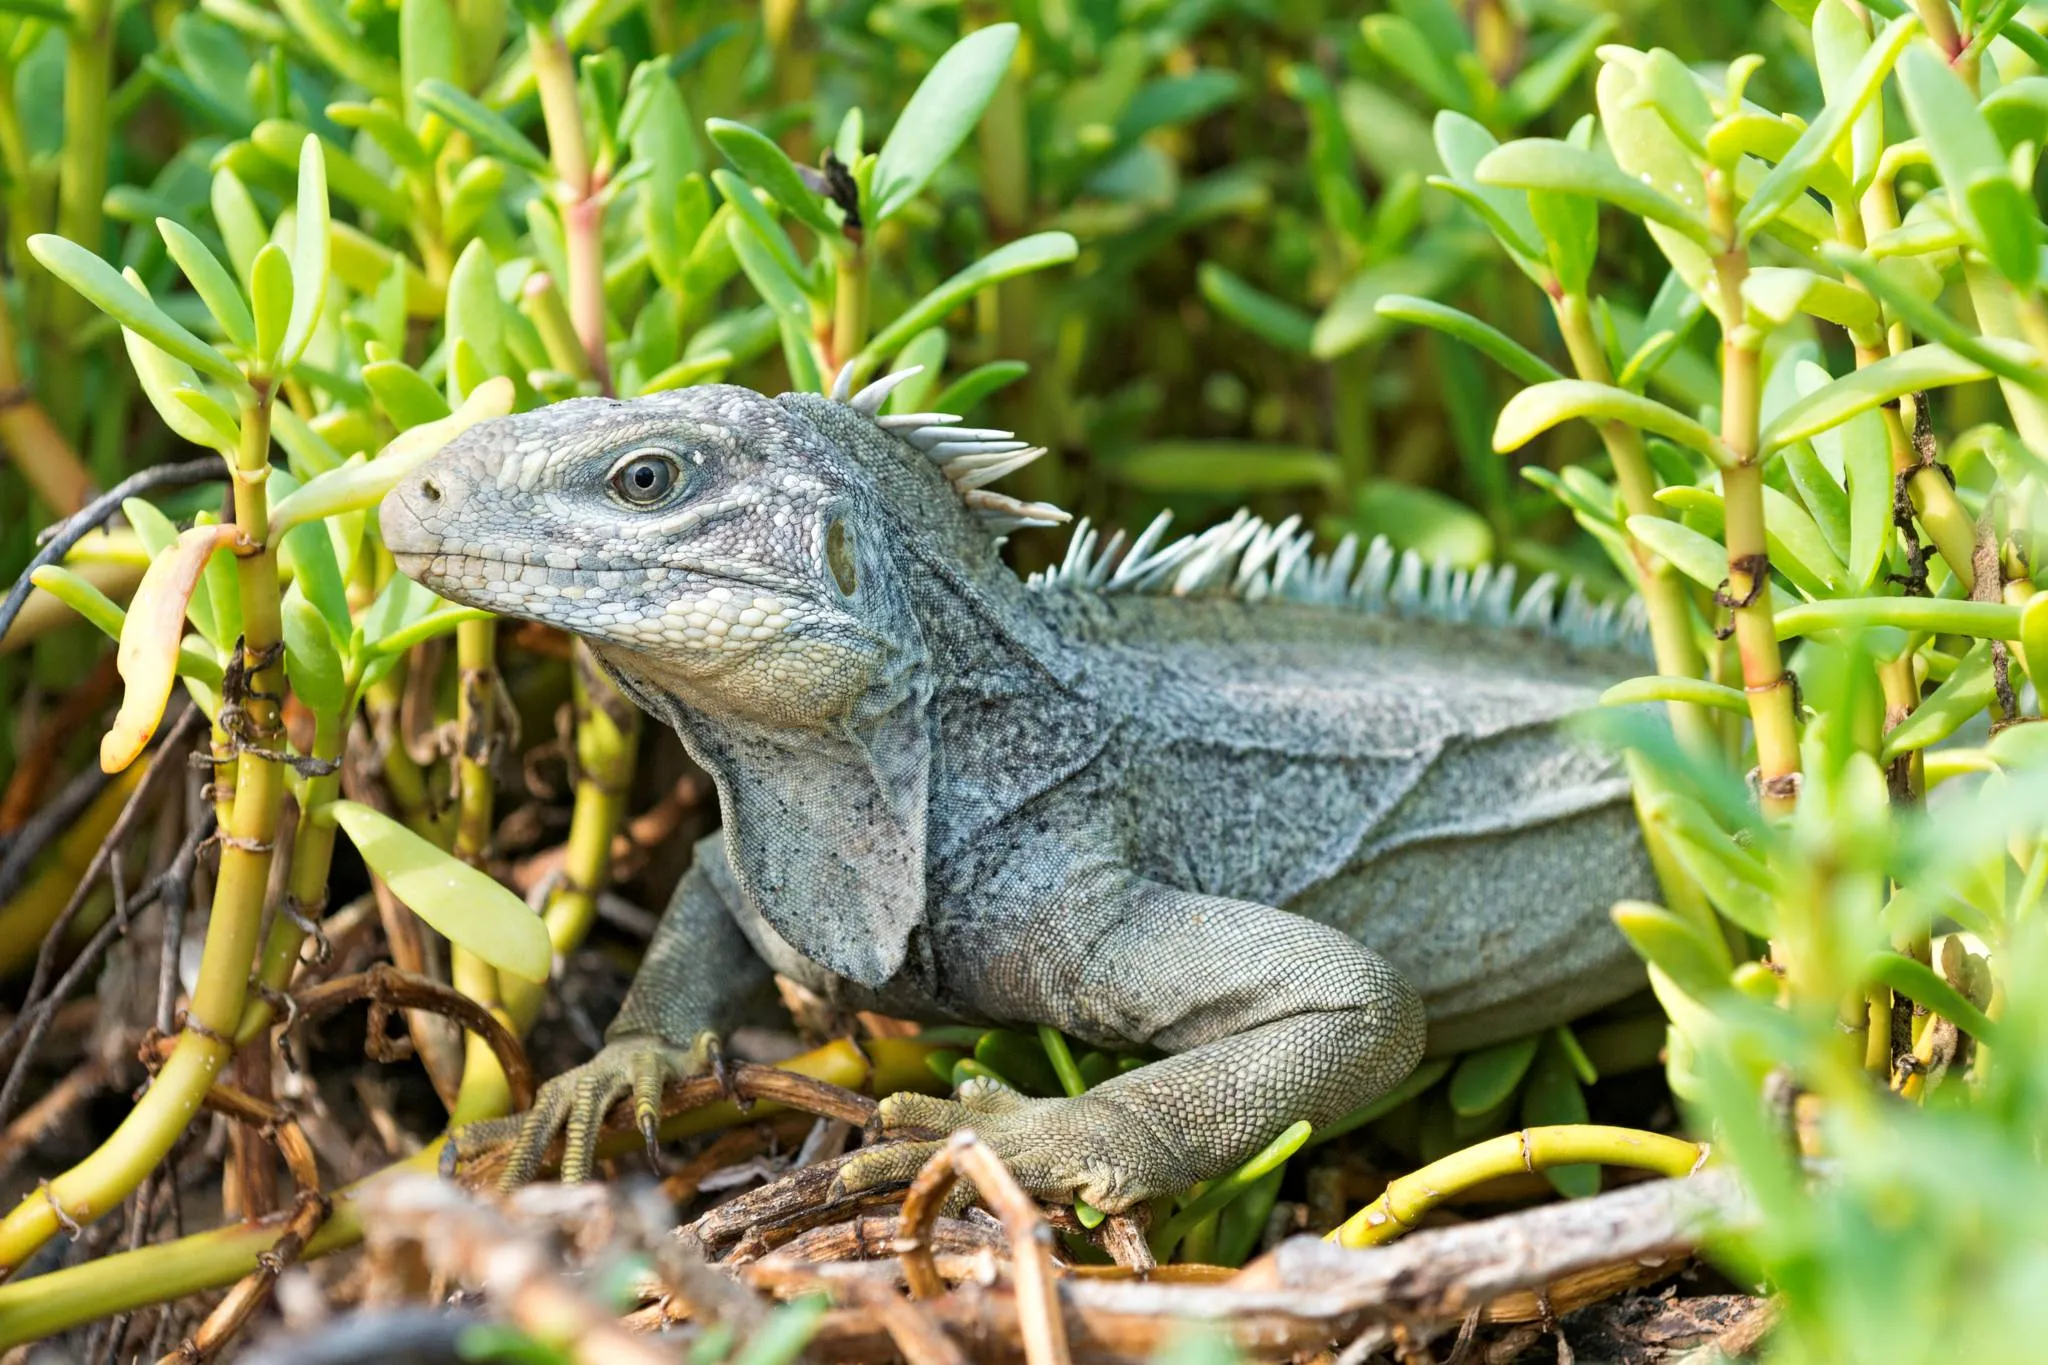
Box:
[457,837,774,1189]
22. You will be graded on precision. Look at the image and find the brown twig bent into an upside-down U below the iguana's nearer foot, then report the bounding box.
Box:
[901,1130,1073,1365]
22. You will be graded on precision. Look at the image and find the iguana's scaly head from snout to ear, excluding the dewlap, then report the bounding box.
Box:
[383,374,1056,726]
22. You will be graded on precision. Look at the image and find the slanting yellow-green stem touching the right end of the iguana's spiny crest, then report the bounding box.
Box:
[1552,295,1720,757]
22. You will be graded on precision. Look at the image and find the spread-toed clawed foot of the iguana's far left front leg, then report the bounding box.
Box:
[455,1033,719,1189]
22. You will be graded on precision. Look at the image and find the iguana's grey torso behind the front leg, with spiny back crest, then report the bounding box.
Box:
[1011,522,1655,1050]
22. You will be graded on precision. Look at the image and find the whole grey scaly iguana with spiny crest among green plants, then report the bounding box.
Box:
[383,370,1653,1212]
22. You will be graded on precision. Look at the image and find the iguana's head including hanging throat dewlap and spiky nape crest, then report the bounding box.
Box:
[381,377,1065,986]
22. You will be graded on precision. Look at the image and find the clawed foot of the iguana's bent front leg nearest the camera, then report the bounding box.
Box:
[840,1081,1196,1214]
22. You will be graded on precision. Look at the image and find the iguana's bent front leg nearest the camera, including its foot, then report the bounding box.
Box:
[842,855,1423,1212]
